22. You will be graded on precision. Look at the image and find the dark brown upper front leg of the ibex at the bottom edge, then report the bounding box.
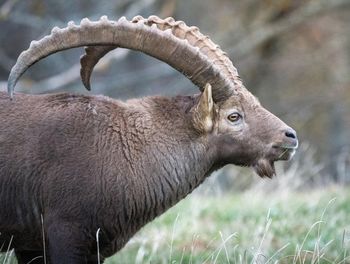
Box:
[47,222,92,264]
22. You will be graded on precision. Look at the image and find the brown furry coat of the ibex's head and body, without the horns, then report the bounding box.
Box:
[0,82,297,264]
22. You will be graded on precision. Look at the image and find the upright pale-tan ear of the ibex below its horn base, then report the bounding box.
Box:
[192,83,215,132]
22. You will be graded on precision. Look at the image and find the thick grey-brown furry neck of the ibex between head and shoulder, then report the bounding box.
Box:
[126,94,217,223]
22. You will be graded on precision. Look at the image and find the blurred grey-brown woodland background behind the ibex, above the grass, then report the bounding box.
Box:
[0,0,350,190]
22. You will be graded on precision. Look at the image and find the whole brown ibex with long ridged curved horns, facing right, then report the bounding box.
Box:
[0,16,298,264]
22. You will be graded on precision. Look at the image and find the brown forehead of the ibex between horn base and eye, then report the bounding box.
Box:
[220,88,261,110]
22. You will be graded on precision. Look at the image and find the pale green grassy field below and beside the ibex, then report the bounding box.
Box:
[0,187,350,264]
